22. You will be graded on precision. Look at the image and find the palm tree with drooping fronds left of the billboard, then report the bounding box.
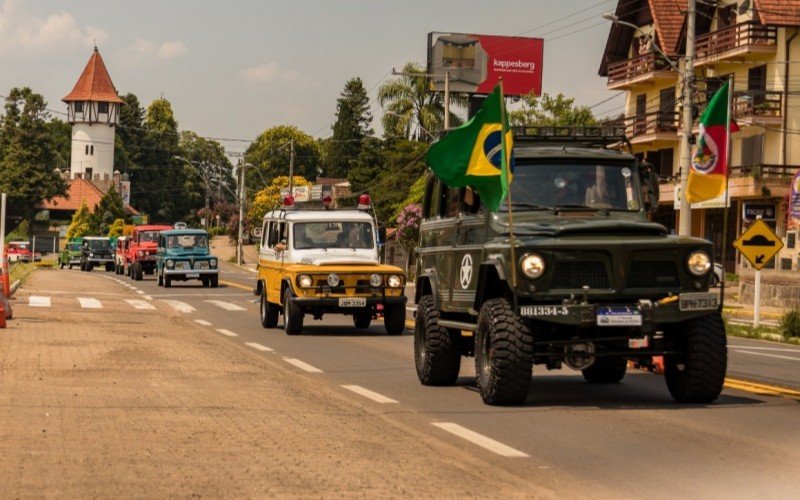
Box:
[378,62,468,141]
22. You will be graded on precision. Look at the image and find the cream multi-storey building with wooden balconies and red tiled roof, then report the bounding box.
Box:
[599,0,800,270]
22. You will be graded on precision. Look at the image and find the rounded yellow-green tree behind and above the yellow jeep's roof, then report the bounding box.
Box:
[245,125,320,190]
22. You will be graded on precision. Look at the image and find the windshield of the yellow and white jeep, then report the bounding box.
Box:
[294,222,375,250]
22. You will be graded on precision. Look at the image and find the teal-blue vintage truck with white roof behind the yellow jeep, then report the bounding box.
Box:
[156,229,219,288]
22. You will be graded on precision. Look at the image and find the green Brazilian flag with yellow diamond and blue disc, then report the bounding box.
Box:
[425,84,513,212]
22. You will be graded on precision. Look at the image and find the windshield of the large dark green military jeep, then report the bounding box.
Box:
[501,163,640,211]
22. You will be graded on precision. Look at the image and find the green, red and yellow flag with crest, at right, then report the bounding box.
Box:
[686,82,739,203]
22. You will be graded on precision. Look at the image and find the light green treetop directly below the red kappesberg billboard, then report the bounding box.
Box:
[508,93,597,127]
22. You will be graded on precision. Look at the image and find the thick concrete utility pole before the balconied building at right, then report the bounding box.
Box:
[678,0,697,236]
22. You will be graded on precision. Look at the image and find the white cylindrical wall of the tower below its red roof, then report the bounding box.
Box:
[70,122,115,180]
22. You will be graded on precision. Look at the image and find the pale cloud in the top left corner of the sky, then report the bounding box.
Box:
[0,0,108,58]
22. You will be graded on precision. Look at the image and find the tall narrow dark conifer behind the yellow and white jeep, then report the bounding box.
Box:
[325,78,373,178]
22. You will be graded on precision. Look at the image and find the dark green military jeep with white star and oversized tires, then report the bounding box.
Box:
[414,127,727,405]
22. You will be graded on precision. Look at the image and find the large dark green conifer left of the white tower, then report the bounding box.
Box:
[0,87,67,223]
